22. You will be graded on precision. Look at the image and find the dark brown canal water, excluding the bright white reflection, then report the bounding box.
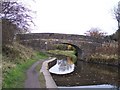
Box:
[51,57,120,87]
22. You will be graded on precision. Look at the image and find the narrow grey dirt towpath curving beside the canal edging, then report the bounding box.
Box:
[25,60,44,88]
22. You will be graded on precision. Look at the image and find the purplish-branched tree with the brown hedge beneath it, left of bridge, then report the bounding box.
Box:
[0,1,34,42]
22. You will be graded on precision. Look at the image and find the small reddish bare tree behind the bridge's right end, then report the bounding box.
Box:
[85,28,106,38]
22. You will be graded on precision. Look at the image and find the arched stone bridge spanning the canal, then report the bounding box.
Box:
[17,33,103,57]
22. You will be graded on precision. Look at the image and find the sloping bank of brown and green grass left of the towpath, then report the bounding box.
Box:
[2,44,47,88]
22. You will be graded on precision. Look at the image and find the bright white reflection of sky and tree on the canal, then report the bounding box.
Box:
[49,57,75,74]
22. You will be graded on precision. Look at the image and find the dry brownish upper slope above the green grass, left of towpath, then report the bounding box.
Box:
[2,43,35,79]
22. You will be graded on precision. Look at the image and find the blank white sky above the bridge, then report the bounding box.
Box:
[25,0,119,34]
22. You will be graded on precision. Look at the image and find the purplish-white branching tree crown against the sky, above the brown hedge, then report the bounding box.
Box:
[0,1,33,32]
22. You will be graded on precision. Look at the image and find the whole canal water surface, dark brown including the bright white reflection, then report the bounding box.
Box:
[50,58,119,90]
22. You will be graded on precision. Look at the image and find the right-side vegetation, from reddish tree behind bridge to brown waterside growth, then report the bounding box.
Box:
[85,28,120,65]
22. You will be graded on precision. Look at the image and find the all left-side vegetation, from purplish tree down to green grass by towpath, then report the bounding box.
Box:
[0,0,47,88]
